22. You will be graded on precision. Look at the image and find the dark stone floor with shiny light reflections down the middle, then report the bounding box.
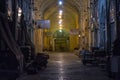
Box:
[17,52,112,80]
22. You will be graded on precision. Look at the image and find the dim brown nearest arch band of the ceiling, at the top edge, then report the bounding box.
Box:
[35,0,83,12]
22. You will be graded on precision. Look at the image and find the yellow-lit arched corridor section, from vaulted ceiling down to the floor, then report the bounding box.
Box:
[34,0,82,52]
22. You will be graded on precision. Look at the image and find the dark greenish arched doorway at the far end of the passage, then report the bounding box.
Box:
[53,30,69,51]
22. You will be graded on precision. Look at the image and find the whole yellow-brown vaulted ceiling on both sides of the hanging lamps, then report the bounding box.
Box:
[34,0,89,32]
